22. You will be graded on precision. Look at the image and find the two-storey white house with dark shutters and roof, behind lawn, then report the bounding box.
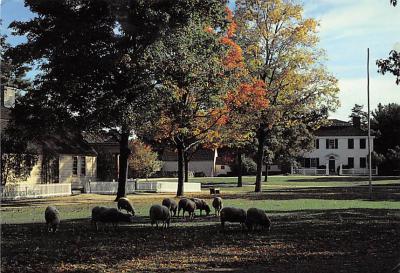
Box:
[292,118,377,175]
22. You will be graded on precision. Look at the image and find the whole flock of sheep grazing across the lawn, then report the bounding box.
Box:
[45,196,271,233]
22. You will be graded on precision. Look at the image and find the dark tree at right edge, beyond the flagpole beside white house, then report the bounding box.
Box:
[371,103,400,174]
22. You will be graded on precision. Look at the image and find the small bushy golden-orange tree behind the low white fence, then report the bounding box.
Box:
[129,140,161,178]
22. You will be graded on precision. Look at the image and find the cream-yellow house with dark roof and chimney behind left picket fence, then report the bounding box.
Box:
[0,87,97,189]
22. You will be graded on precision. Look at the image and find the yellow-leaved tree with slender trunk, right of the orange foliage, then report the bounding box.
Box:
[235,0,338,192]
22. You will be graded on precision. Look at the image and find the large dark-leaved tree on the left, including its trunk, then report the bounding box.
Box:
[11,0,222,199]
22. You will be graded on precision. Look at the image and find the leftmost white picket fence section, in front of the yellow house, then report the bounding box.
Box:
[1,183,71,200]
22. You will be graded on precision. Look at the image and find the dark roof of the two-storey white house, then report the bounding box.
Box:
[314,119,368,136]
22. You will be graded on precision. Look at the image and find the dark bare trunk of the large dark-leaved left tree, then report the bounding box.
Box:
[115,130,131,201]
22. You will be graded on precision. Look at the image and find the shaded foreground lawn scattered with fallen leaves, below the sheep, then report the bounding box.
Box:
[1,209,400,273]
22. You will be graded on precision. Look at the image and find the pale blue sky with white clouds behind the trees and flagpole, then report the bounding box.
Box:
[0,0,400,120]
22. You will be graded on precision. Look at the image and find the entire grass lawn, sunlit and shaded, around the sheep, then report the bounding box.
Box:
[1,176,400,272]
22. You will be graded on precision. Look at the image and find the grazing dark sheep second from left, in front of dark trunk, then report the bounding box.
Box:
[92,207,133,230]
